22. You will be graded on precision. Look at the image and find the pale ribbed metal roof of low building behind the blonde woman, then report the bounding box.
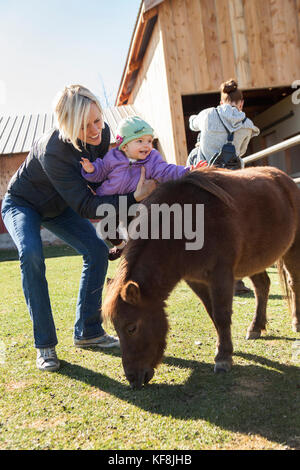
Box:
[0,105,138,155]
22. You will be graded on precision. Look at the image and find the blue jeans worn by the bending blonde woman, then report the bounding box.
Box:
[2,195,108,348]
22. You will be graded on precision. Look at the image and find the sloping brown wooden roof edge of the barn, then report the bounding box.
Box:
[116,0,164,105]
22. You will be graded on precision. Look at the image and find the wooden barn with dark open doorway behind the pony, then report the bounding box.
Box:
[116,0,300,174]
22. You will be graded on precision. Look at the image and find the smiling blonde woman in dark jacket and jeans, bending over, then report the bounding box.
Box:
[2,85,155,371]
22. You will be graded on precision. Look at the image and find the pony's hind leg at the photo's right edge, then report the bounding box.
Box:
[283,255,300,333]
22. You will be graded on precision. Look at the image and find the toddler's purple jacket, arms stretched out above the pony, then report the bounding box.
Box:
[81,147,190,196]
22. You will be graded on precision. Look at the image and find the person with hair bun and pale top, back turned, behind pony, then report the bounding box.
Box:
[187,79,260,294]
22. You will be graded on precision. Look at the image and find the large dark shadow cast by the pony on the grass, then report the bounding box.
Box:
[59,352,300,448]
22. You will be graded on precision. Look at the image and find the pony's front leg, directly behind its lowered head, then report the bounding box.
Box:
[210,268,235,372]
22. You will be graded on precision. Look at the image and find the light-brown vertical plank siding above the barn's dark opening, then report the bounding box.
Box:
[159,0,300,95]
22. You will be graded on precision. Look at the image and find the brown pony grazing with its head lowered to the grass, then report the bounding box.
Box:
[103,167,300,388]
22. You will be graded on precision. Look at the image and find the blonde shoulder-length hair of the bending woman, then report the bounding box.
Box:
[54,85,102,151]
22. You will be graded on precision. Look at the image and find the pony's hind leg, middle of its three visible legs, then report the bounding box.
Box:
[246,271,270,339]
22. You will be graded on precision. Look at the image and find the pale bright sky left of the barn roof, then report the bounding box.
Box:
[0,0,141,116]
